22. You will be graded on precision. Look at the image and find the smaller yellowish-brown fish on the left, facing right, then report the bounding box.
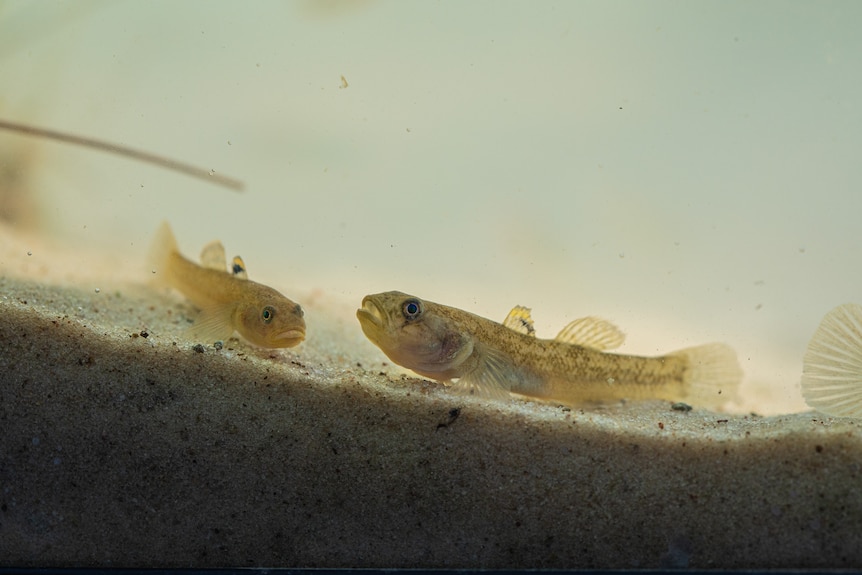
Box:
[150,222,305,348]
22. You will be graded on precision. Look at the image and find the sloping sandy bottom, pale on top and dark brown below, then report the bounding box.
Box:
[0,278,862,568]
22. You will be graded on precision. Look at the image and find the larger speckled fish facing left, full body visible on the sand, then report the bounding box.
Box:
[356,292,742,407]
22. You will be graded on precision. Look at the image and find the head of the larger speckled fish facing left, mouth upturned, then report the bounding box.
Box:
[356,291,480,381]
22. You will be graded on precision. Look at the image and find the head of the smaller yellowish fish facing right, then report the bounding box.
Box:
[235,286,305,348]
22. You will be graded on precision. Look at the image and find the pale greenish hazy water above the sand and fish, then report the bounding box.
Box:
[0,0,862,414]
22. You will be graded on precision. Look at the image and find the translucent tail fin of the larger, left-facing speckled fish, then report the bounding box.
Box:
[670,343,742,408]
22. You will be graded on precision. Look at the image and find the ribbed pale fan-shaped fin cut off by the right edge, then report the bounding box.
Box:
[802,303,862,417]
